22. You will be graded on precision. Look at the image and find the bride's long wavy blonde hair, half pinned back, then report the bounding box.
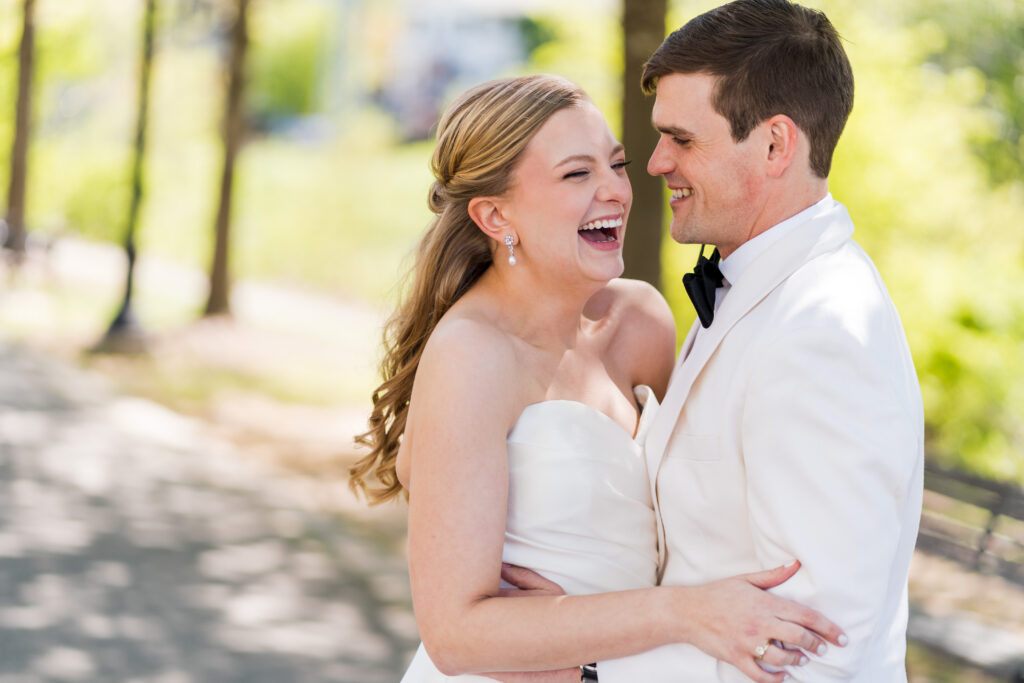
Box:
[349,75,588,504]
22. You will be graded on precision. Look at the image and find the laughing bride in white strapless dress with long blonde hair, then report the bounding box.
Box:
[351,75,840,683]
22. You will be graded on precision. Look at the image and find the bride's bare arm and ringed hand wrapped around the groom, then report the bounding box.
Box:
[399,321,838,681]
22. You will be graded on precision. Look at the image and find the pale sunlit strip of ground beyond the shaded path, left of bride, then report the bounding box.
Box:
[0,239,380,413]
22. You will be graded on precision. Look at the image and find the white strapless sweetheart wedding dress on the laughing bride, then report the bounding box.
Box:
[401,386,657,683]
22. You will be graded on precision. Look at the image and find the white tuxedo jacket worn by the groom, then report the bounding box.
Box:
[598,202,924,683]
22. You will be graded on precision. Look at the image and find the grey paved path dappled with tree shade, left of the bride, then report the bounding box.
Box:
[0,343,416,683]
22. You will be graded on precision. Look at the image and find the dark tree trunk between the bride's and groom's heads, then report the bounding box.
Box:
[623,0,668,289]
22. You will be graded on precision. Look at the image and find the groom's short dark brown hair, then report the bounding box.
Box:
[641,0,853,178]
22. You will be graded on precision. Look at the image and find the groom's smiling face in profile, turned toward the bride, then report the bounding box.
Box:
[647,74,764,257]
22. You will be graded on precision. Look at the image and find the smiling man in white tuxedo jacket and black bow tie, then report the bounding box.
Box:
[597,0,924,683]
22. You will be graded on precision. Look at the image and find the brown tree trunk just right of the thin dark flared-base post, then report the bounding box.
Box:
[203,0,250,315]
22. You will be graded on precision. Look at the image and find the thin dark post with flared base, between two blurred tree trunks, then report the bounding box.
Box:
[93,0,157,352]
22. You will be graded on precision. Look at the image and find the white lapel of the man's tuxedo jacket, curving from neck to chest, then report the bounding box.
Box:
[644,203,853,483]
